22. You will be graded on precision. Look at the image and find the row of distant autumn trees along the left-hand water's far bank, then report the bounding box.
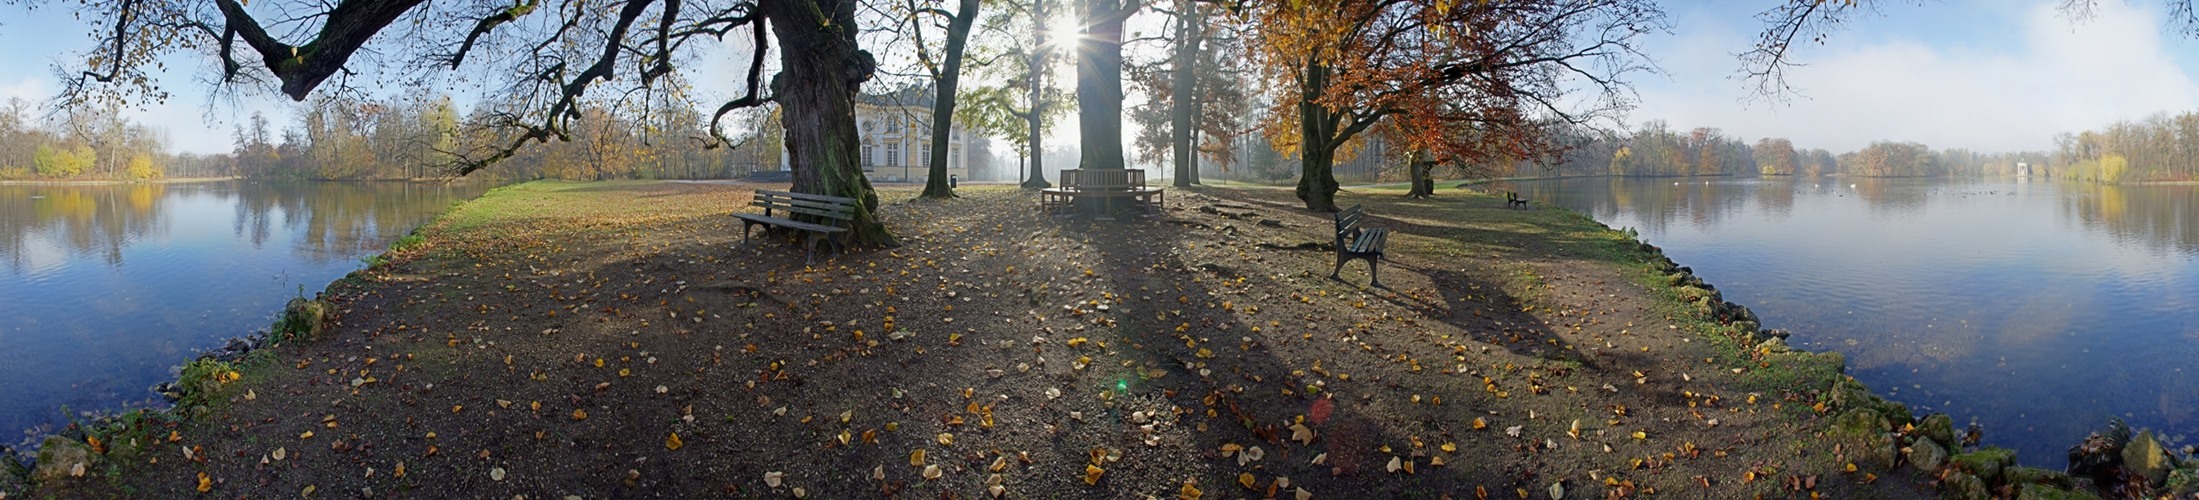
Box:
[0,97,781,181]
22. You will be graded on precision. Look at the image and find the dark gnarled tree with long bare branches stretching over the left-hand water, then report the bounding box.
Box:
[38,0,895,244]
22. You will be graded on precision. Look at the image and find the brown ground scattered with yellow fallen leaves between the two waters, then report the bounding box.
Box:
[44,183,1929,498]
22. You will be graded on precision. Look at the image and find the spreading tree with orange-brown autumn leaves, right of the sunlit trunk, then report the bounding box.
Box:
[1247,0,1662,211]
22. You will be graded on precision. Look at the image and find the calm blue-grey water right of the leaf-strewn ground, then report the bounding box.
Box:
[1517,178,2199,467]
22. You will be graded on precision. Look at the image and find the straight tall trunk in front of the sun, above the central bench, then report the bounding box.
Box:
[1078,0,1128,170]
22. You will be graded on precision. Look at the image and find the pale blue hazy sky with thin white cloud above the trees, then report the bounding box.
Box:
[0,0,2199,154]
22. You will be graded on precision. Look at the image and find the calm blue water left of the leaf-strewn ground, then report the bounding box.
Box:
[0,181,488,445]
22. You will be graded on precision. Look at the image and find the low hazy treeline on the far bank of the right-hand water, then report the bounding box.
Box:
[1515,121,2049,176]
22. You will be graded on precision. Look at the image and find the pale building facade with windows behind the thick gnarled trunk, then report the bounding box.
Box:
[778,86,976,183]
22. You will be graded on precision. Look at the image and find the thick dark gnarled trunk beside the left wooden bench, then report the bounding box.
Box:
[759,0,897,244]
